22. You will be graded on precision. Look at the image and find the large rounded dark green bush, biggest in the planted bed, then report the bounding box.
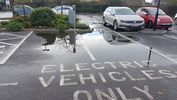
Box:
[30,7,57,27]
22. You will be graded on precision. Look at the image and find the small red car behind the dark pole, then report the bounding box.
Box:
[136,7,173,30]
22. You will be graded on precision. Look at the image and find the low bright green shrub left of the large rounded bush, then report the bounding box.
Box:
[6,21,23,31]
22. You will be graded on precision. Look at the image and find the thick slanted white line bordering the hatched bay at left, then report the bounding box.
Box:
[0,31,33,64]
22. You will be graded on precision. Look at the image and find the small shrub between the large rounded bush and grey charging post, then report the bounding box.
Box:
[56,19,69,33]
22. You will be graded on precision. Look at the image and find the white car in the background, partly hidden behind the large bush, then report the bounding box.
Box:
[52,5,73,15]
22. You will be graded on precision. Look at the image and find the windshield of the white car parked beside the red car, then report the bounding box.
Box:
[115,8,135,15]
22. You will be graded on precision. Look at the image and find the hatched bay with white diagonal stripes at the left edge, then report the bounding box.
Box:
[0,32,32,64]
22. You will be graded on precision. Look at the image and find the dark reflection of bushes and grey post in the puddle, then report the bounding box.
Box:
[36,32,79,53]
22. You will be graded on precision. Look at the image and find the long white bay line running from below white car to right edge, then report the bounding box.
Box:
[105,27,177,64]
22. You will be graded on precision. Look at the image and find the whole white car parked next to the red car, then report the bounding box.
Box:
[103,7,145,30]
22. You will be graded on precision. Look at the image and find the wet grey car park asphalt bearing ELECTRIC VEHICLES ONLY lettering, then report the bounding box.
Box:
[0,15,177,100]
